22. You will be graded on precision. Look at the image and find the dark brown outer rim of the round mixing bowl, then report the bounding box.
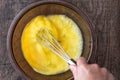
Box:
[7,0,94,80]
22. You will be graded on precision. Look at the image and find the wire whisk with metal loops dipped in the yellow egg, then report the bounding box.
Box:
[36,29,76,65]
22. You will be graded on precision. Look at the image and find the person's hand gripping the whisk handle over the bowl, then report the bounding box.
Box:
[70,57,114,80]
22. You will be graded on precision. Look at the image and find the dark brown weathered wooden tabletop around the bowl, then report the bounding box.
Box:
[0,0,120,80]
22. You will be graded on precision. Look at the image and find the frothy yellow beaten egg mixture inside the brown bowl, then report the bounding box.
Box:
[21,15,83,75]
